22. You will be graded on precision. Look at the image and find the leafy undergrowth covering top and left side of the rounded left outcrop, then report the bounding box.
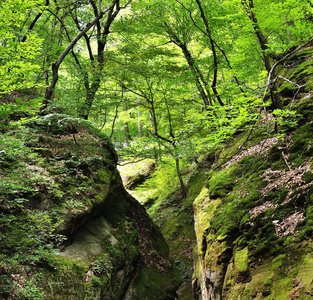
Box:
[0,115,116,299]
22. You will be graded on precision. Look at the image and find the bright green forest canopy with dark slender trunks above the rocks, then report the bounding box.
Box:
[0,0,313,169]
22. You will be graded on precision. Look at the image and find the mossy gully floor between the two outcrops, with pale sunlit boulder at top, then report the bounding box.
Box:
[121,161,197,300]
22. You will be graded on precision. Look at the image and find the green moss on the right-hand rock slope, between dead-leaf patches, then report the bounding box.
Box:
[191,50,313,300]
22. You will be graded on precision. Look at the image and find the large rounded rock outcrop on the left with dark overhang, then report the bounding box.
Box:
[0,114,177,300]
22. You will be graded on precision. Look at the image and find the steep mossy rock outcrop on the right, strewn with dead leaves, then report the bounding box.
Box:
[193,46,313,300]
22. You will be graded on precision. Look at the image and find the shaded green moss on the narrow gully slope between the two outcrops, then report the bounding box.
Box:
[122,163,197,299]
